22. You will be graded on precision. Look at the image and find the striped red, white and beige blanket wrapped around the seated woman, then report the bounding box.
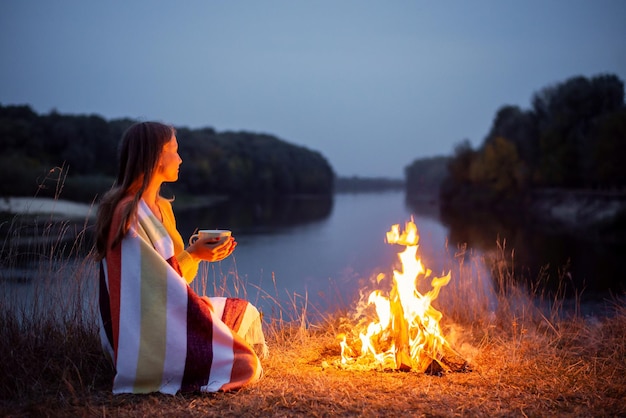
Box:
[100,201,264,394]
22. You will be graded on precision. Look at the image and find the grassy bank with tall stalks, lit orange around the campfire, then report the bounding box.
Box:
[0,214,626,417]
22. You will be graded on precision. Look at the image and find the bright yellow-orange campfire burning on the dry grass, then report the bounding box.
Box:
[339,221,469,374]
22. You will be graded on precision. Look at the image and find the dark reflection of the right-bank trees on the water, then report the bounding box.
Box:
[434,204,626,298]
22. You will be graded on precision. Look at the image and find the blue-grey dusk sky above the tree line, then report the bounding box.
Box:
[0,0,626,178]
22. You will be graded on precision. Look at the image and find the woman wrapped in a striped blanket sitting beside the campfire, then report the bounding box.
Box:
[96,122,267,394]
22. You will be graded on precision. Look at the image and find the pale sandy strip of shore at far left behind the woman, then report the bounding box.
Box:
[0,197,96,219]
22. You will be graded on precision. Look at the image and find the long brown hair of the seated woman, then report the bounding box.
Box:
[96,122,176,261]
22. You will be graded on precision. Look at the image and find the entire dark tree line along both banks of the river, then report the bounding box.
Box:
[6,74,626,209]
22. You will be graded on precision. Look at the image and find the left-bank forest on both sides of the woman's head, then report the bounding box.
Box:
[0,105,335,202]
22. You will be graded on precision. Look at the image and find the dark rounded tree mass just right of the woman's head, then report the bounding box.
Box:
[178,129,334,195]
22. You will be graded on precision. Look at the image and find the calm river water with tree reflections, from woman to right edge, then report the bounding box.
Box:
[5,192,626,313]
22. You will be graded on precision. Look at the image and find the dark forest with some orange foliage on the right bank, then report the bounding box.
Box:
[405,74,626,209]
